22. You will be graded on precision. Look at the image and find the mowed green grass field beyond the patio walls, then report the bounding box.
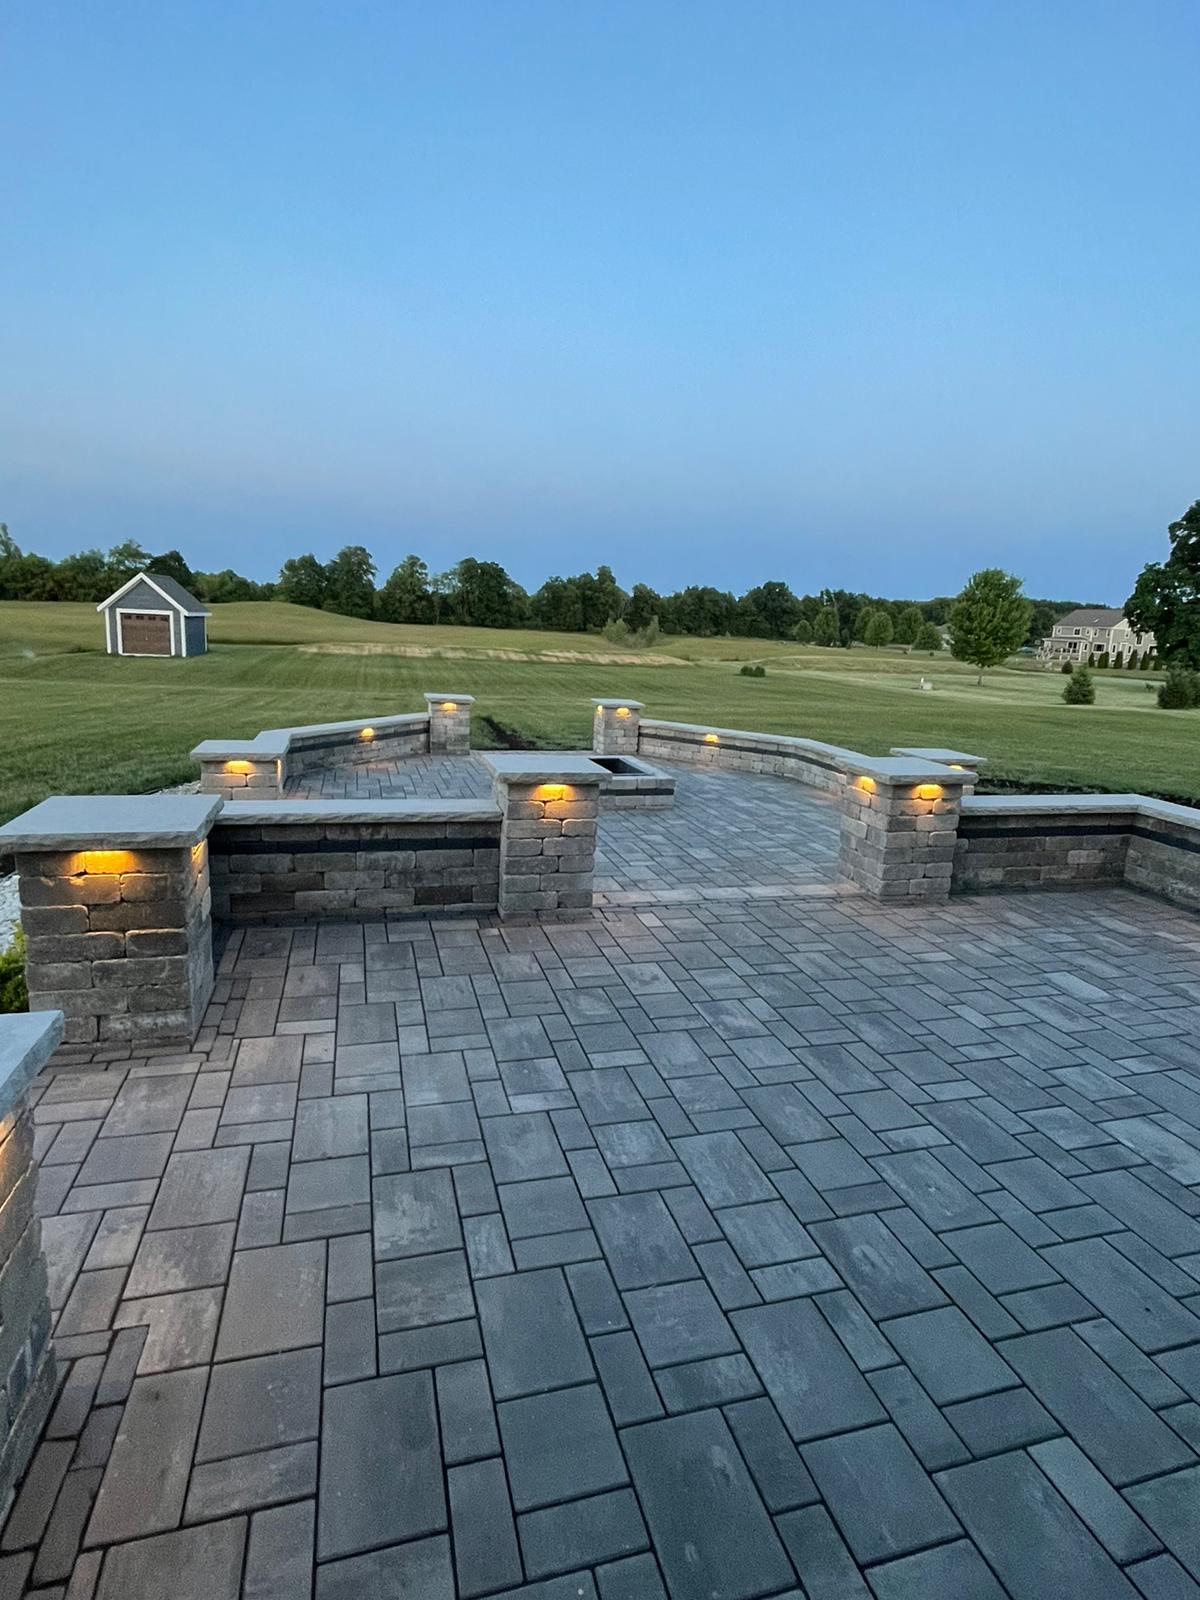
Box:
[0,602,1200,818]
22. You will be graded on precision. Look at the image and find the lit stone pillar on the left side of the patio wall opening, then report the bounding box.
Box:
[483,750,603,920]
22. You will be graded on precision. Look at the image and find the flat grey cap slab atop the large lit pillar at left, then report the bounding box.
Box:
[0,795,221,853]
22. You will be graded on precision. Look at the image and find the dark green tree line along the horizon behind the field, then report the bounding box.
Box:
[0,523,1078,650]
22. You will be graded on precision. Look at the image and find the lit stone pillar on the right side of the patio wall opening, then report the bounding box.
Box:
[838,757,963,902]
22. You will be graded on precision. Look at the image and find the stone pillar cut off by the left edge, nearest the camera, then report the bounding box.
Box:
[0,1011,62,1509]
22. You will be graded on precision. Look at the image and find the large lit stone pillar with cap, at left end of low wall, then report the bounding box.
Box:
[0,795,221,1046]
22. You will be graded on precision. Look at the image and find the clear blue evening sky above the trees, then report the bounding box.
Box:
[0,0,1200,602]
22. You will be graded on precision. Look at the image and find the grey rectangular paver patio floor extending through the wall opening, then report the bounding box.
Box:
[0,762,1200,1600]
